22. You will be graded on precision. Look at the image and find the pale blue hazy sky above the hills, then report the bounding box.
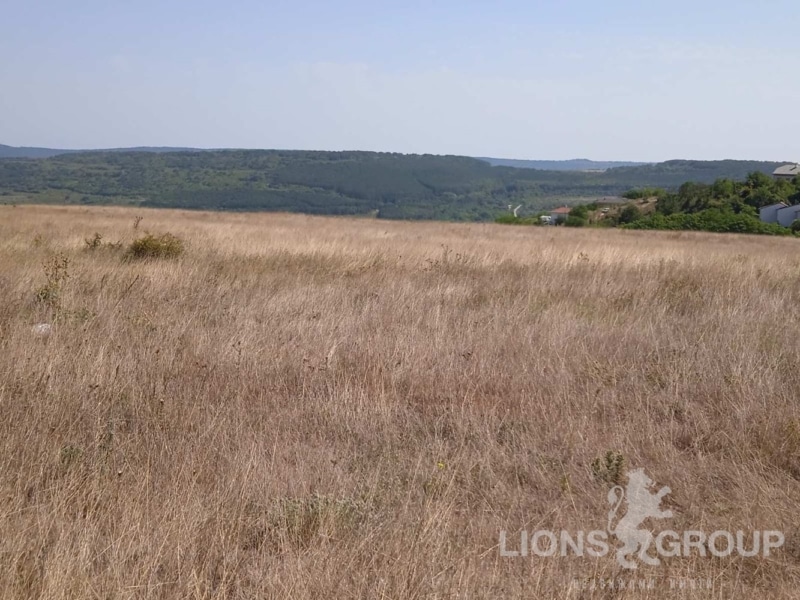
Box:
[0,0,800,161]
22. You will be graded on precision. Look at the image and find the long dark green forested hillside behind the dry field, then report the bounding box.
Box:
[0,150,780,220]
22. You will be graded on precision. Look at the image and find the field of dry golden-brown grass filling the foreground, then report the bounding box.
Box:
[0,206,800,599]
